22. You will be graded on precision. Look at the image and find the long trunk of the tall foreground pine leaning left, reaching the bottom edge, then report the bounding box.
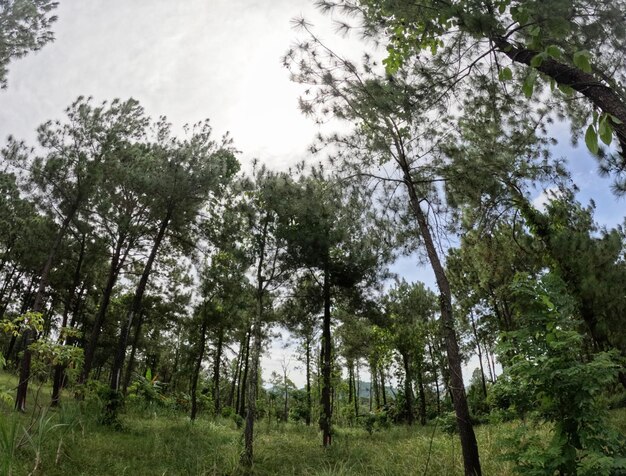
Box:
[399,155,482,476]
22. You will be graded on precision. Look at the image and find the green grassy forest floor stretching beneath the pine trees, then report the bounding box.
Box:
[0,374,626,476]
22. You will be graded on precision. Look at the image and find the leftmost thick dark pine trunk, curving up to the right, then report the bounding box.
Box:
[15,209,78,412]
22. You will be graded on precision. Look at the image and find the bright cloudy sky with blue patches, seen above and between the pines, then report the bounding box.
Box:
[0,0,625,385]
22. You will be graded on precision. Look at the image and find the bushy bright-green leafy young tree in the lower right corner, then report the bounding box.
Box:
[496,274,626,475]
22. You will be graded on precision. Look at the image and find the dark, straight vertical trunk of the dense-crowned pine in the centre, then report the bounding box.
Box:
[320,262,332,448]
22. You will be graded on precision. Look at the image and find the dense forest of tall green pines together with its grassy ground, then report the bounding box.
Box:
[0,0,626,476]
